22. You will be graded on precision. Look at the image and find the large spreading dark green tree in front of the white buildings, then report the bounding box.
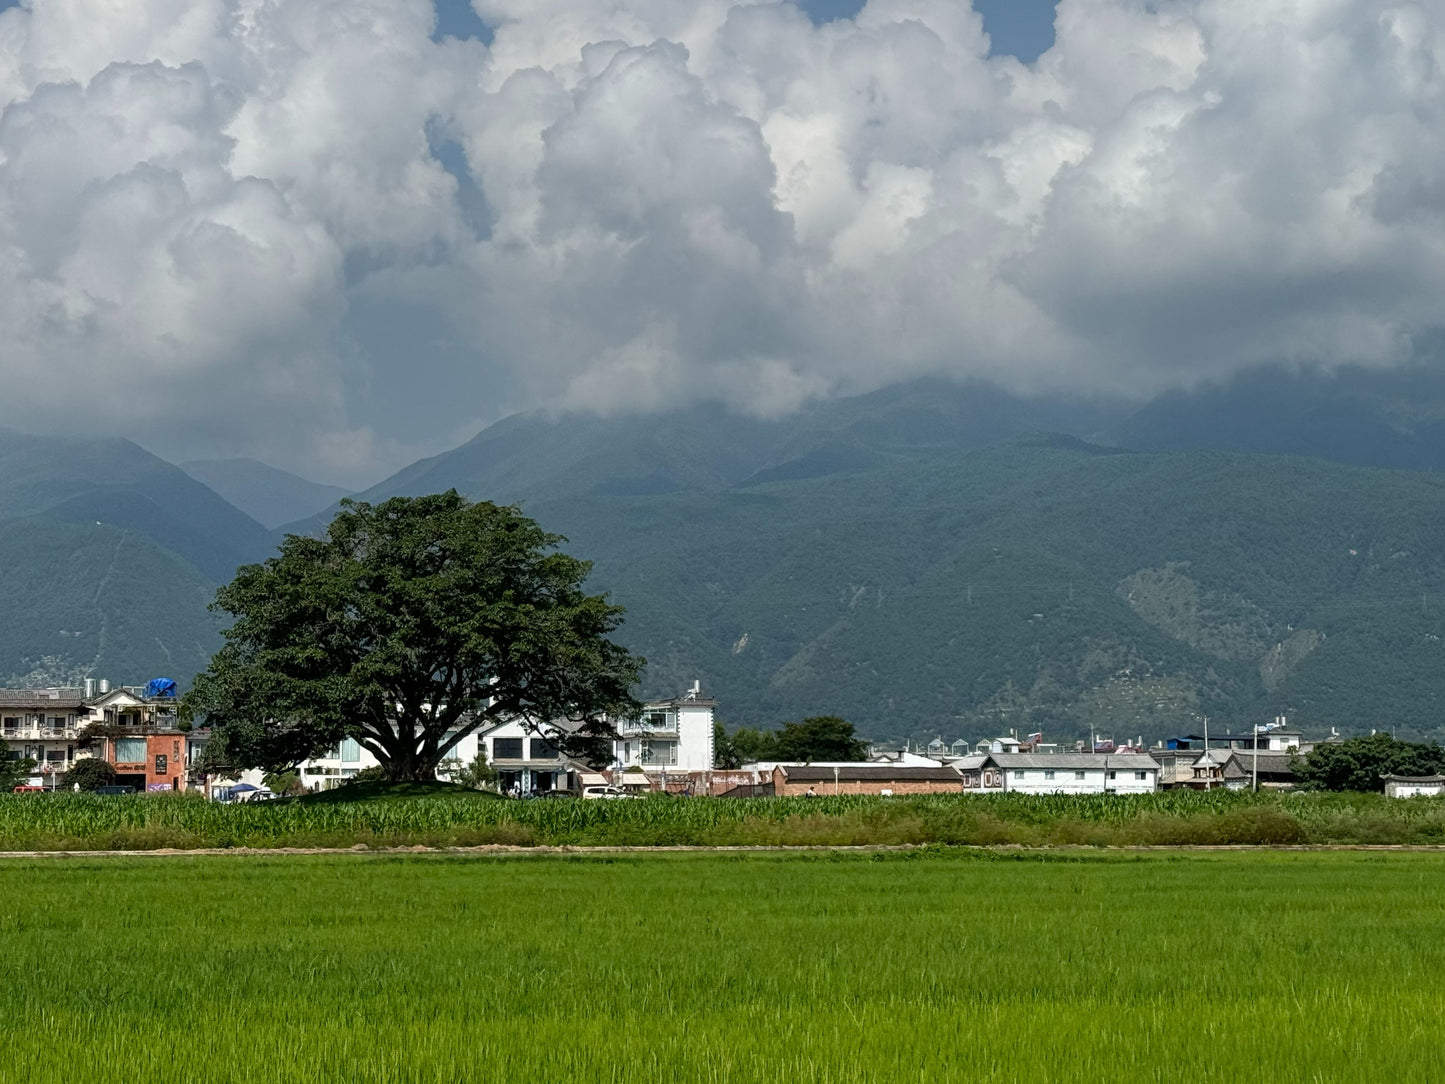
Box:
[185,490,643,782]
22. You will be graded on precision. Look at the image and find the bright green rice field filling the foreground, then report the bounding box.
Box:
[0,848,1445,1084]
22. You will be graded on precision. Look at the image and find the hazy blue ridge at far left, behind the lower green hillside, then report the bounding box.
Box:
[0,429,273,581]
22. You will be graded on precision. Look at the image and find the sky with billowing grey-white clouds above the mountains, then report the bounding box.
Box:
[0,0,1445,484]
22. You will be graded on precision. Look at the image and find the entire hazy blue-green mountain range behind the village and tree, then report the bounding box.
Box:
[8,370,1445,739]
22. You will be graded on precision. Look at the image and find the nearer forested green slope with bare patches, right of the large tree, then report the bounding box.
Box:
[523,442,1445,739]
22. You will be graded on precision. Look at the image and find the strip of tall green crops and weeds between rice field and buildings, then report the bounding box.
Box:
[0,791,1445,850]
